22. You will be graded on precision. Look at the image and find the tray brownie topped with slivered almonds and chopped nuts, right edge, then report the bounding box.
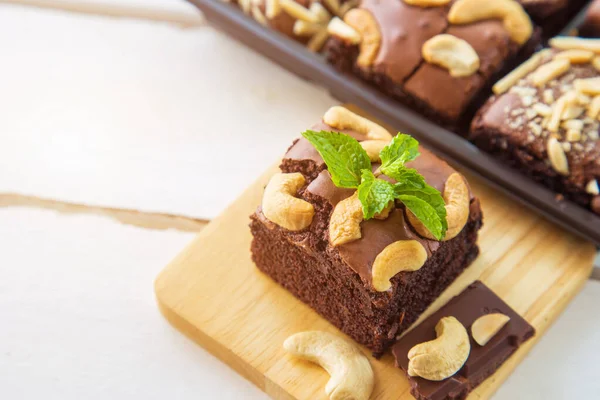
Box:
[470,38,600,214]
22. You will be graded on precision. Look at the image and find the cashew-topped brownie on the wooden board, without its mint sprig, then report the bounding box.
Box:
[250,107,482,355]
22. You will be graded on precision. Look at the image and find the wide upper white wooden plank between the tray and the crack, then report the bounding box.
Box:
[0,6,334,218]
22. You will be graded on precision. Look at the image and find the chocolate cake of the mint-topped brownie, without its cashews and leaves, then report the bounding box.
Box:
[250,110,482,355]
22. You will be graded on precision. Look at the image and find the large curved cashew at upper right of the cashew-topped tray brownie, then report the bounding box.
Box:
[448,0,533,45]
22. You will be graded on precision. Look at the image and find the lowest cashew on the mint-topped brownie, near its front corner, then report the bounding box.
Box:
[371,240,427,292]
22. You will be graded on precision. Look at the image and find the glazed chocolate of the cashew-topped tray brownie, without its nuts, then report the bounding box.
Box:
[326,0,539,132]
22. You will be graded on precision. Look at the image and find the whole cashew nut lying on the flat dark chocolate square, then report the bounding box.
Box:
[408,317,471,381]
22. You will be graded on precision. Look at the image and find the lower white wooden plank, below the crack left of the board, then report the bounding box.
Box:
[0,208,266,400]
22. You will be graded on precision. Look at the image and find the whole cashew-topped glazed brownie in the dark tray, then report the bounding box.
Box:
[325,0,540,130]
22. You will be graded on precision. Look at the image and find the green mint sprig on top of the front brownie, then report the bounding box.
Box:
[302,130,448,240]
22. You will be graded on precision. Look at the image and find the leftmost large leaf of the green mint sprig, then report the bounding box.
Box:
[302,130,371,189]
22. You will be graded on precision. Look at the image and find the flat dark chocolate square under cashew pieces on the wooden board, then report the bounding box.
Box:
[392,281,535,400]
